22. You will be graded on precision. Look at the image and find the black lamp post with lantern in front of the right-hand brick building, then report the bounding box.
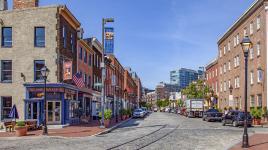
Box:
[241,36,252,148]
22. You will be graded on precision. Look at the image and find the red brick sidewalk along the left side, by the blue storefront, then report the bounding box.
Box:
[0,118,126,137]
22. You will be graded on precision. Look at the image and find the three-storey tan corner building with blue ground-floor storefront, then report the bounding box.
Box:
[0,0,80,125]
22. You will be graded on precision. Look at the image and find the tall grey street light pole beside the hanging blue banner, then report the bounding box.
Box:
[100,18,114,128]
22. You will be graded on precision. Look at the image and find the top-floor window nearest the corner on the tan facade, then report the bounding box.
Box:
[34,27,46,47]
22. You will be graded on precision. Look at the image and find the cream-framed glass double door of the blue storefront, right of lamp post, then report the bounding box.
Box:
[47,101,61,124]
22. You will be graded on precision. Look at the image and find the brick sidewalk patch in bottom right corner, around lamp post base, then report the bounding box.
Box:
[230,134,268,150]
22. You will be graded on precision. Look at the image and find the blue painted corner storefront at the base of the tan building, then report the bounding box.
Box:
[24,83,79,125]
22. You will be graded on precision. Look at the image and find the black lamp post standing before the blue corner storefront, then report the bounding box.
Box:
[41,66,49,135]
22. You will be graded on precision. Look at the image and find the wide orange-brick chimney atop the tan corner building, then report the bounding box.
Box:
[13,0,39,9]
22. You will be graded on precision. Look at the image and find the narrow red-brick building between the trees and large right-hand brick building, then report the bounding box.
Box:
[205,59,219,106]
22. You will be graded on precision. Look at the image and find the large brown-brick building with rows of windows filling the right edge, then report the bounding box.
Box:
[218,0,268,109]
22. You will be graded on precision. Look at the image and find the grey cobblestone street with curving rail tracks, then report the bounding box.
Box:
[0,113,264,150]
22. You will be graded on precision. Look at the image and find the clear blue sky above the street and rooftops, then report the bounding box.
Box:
[16,0,254,88]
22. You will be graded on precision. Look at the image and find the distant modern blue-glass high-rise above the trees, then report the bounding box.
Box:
[170,68,198,89]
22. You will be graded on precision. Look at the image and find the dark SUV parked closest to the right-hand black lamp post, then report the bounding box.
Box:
[222,111,252,127]
